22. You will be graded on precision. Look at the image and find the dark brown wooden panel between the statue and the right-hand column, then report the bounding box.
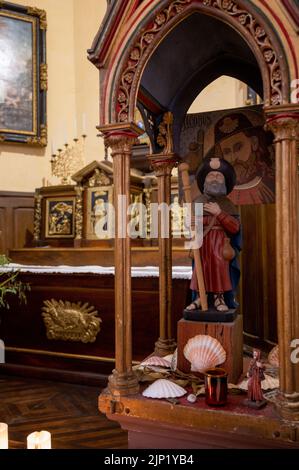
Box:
[240,204,277,349]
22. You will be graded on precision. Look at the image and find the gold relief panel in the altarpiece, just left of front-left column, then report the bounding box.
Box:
[86,186,114,240]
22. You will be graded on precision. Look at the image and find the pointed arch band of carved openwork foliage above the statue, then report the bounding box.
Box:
[116,0,283,122]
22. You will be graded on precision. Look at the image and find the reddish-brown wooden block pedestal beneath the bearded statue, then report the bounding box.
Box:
[178,315,243,384]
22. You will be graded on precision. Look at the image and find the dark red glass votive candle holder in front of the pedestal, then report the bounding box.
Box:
[205,367,227,406]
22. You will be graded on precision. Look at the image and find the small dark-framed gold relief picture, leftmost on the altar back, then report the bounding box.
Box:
[45,197,76,238]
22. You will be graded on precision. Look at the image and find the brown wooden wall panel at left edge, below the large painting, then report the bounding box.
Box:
[0,192,34,255]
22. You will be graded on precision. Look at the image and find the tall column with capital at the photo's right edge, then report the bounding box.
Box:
[265,105,299,421]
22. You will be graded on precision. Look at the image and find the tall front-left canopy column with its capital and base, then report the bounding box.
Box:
[100,124,140,397]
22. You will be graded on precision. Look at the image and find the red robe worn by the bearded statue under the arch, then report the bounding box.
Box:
[190,210,240,294]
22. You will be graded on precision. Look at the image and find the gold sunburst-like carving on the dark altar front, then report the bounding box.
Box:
[42,299,102,343]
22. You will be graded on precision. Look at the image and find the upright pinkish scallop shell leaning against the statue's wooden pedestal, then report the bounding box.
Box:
[184,335,226,372]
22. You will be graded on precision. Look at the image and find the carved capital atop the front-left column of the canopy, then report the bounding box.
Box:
[97,123,144,157]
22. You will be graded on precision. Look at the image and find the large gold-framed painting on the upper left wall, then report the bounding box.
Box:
[0,2,47,146]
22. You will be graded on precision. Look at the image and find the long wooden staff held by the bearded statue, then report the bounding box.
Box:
[179,163,208,311]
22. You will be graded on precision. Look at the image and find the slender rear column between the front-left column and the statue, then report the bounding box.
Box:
[150,154,177,356]
